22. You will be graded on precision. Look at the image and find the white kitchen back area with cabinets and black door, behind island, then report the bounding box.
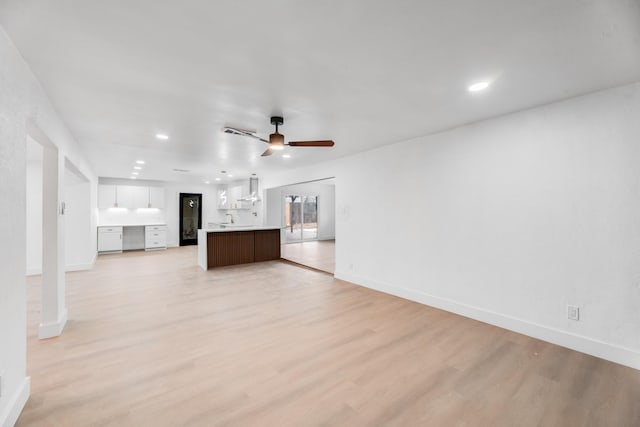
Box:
[97,178,262,254]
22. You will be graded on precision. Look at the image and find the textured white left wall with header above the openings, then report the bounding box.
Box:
[0,27,97,426]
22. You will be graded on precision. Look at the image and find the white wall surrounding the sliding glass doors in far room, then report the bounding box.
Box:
[266,182,336,240]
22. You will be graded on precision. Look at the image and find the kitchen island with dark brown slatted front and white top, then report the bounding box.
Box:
[198,226,280,270]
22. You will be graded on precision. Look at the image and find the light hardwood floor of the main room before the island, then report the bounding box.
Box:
[17,248,640,427]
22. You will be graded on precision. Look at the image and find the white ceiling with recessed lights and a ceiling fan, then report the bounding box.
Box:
[0,0,640,182]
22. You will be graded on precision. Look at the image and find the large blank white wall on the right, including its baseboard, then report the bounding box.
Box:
[269,84,640,368]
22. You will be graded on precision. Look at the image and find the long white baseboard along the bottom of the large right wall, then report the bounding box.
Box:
[334,271,640,370]
